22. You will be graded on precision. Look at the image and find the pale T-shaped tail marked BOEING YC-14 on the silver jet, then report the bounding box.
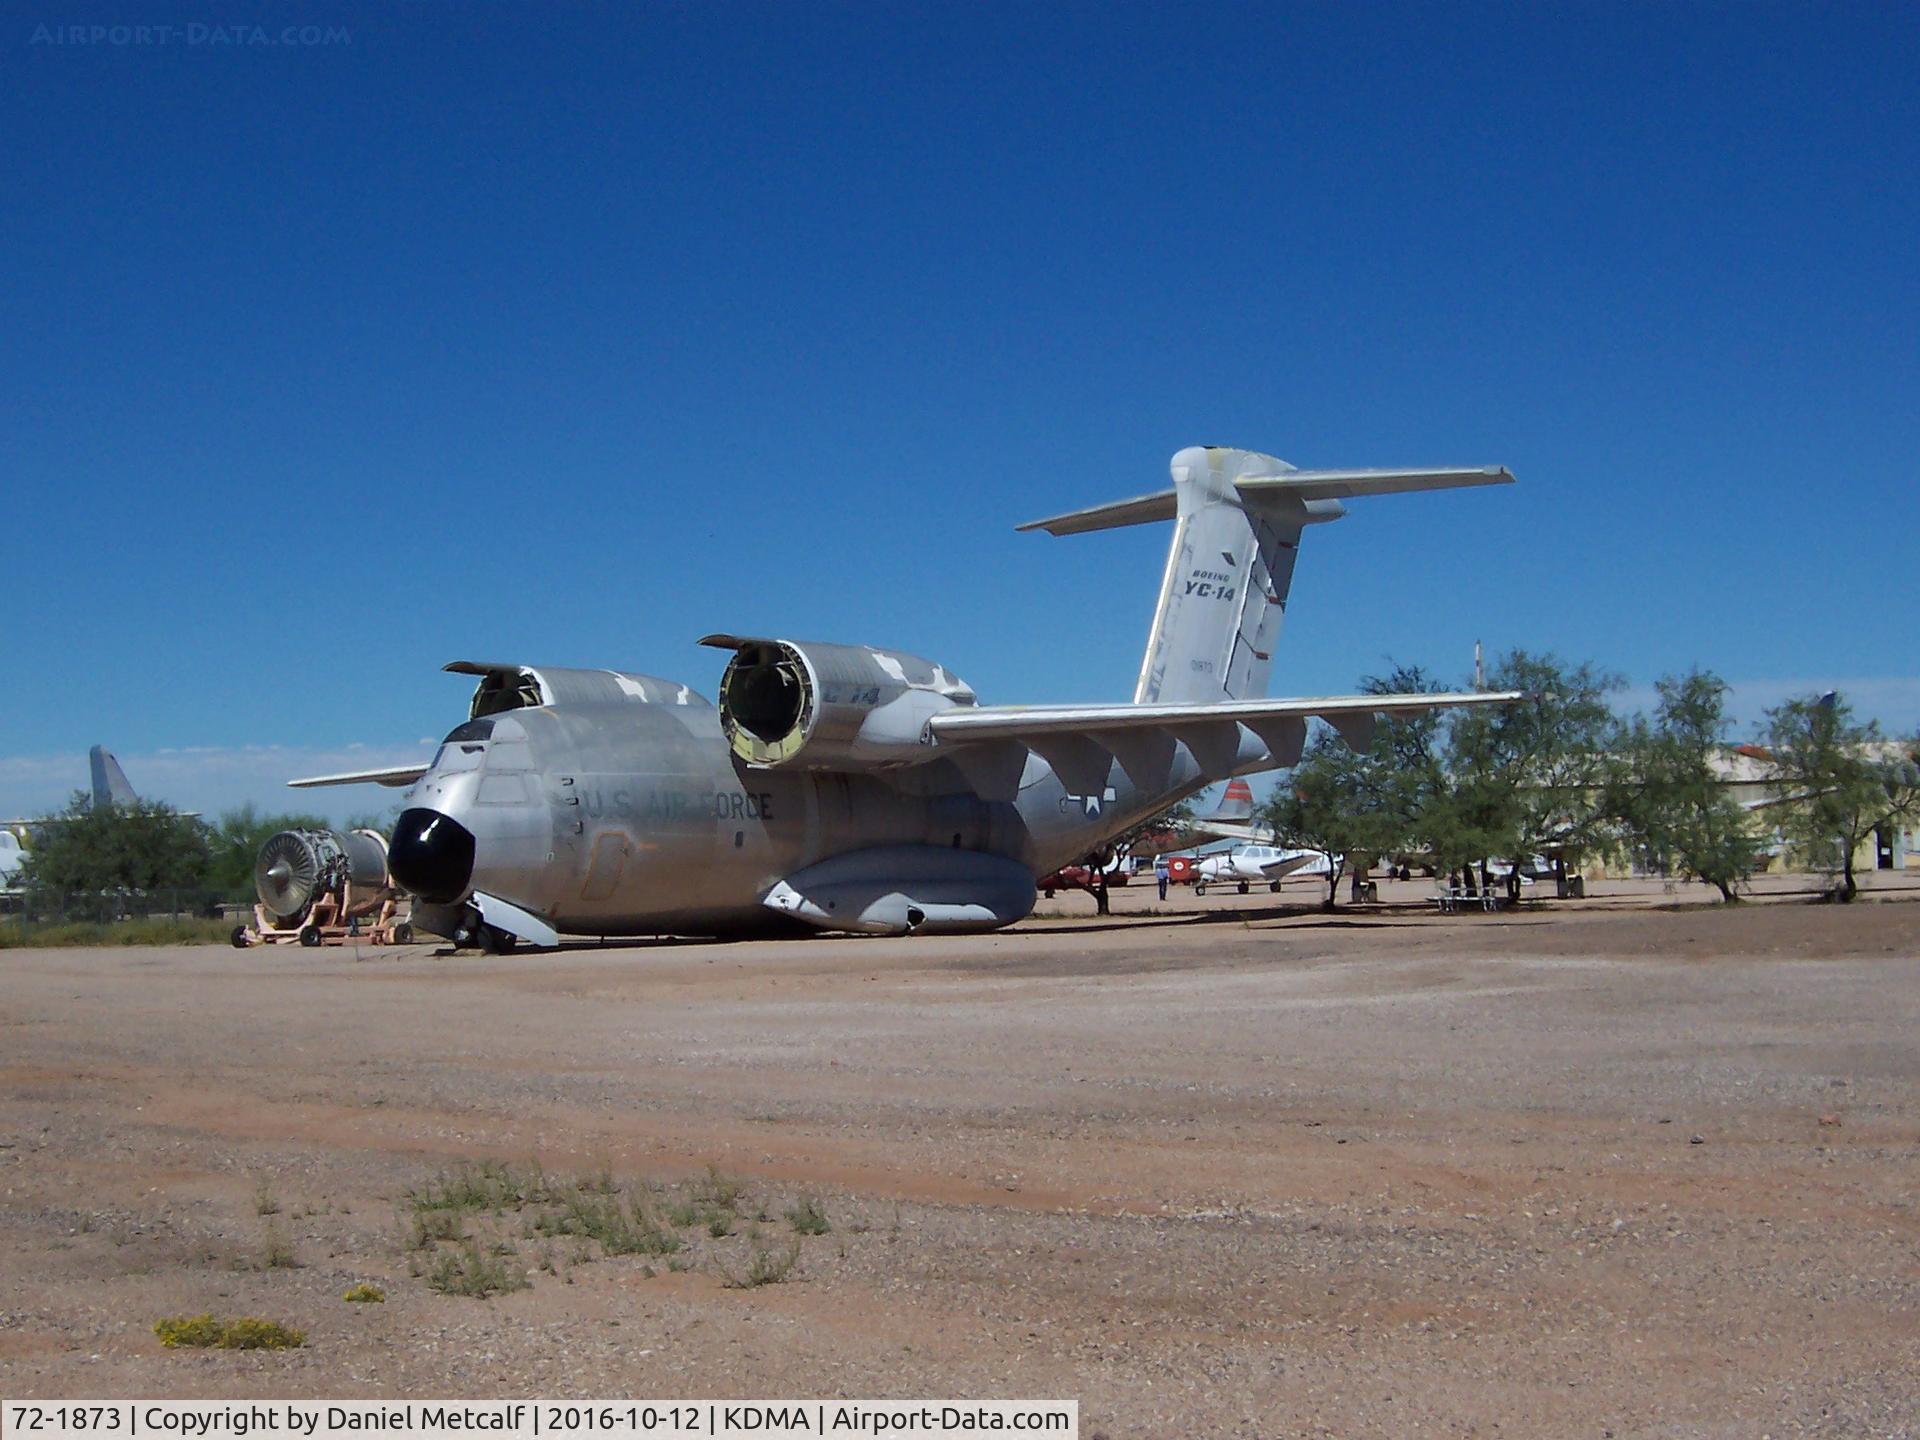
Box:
[1020,445,1513,705]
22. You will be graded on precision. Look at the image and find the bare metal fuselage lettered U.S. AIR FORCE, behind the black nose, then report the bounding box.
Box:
[418,695,1206,935]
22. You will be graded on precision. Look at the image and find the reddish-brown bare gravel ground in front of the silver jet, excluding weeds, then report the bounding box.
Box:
[0,887,1920,1440]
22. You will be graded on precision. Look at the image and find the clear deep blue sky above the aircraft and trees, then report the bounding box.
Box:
[0,4,1920,812]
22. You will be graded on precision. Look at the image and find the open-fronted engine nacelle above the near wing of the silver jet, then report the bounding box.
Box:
[701,636,975,770]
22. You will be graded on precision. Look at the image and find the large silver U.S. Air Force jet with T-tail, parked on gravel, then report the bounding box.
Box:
[292,447,1519,948]
